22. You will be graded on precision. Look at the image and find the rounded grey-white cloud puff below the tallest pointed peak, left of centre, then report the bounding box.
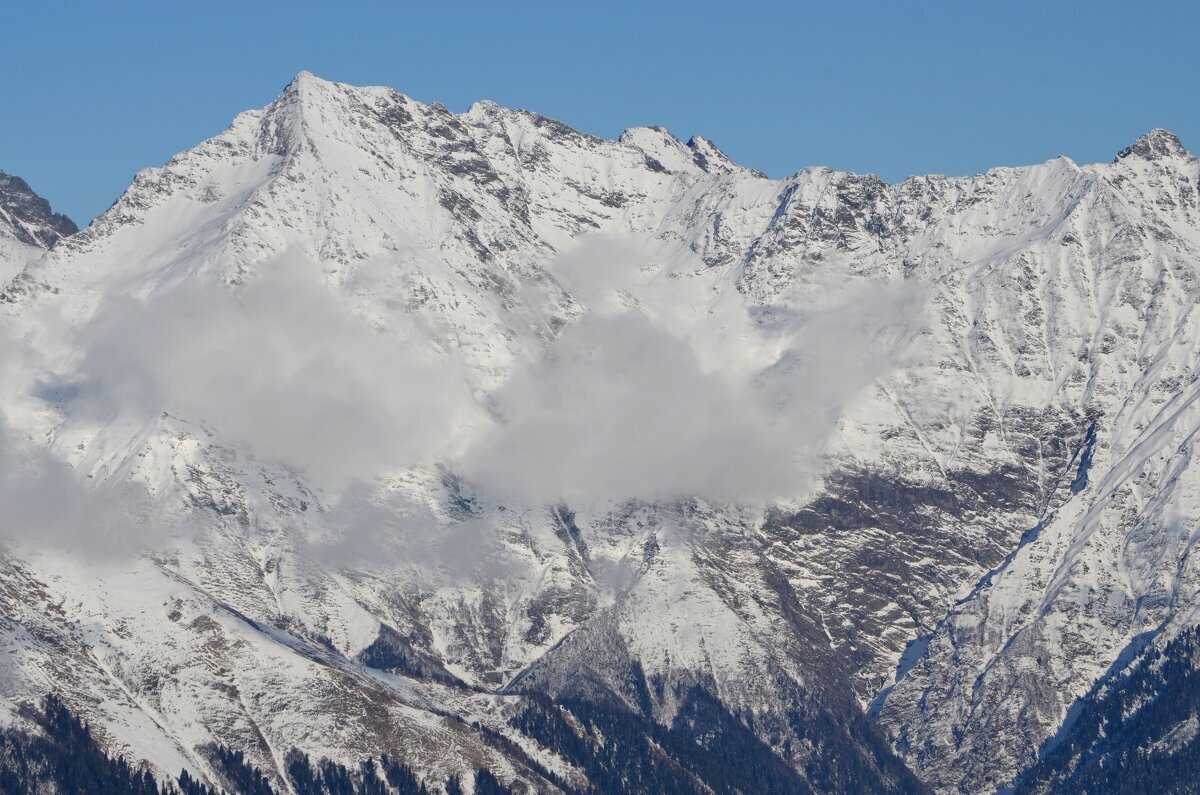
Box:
[57,257,474,490]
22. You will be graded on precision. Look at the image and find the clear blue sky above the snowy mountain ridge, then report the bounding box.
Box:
[0,0,1200,223]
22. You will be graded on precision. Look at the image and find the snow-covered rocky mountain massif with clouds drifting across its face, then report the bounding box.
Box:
[0,73,1200,793]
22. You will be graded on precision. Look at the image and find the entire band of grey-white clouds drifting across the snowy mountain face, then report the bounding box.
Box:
[0,241,925,559]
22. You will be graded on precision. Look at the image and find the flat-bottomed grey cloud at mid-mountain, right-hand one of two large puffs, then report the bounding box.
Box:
[460,276,923,502]
